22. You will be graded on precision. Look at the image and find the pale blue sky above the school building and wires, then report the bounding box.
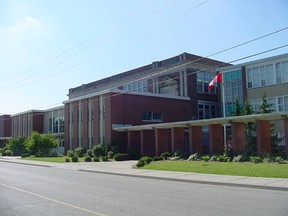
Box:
[0,0,288,115]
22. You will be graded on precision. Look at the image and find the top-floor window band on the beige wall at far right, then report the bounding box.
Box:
[247,61,288,88]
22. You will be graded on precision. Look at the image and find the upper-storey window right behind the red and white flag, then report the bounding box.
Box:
[197,72,217,94]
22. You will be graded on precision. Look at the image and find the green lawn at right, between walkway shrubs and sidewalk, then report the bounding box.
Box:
[141,161,288,178]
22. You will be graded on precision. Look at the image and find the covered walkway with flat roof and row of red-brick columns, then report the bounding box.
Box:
[113,112,288,156]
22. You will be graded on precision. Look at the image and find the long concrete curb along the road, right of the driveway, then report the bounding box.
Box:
[78,169,288,192]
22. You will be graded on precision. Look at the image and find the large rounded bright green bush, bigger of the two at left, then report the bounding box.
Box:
[25,131,59,156]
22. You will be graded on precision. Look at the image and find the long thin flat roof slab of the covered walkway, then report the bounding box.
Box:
[113,112,288,132]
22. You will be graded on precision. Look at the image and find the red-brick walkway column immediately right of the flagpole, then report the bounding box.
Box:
[231,122,246,154]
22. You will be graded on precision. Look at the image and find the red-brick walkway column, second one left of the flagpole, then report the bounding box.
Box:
[189,126,203,154]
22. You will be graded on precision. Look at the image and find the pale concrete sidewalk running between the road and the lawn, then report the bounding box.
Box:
[0,157,288,191]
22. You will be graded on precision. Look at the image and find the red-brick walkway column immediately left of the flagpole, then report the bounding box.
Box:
[209,124,224,155]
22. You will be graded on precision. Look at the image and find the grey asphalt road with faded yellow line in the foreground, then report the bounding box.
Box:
[0,162,288,216]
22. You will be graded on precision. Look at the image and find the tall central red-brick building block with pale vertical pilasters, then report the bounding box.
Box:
[64,53,227,150]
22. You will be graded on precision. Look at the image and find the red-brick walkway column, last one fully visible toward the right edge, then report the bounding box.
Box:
[256,120,271,154]
